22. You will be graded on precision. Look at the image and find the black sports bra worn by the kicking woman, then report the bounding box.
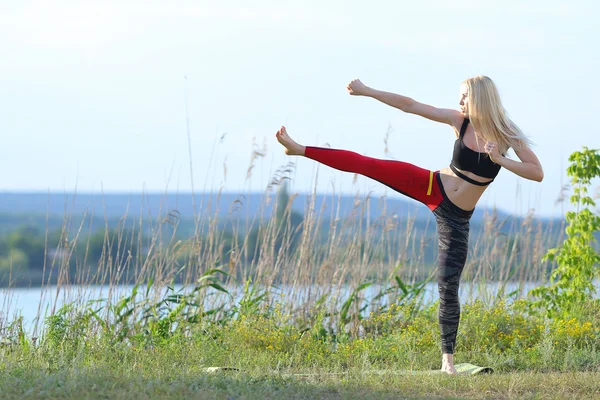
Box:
[450,118,501,186]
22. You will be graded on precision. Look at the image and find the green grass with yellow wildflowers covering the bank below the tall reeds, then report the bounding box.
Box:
[0,296,600,399]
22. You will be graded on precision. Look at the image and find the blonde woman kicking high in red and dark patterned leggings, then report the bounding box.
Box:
[276,76,544,374]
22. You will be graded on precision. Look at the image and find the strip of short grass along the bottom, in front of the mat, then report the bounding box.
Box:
[0,365,600,399]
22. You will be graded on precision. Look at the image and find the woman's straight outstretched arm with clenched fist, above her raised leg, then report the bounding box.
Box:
[348,79,464,127]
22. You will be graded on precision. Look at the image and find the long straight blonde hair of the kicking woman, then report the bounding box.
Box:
[463,75,532,154]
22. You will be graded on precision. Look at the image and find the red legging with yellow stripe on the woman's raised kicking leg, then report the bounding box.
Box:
[304,146,444,211]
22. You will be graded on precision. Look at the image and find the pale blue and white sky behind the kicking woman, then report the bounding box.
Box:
[0,0,600,217]
